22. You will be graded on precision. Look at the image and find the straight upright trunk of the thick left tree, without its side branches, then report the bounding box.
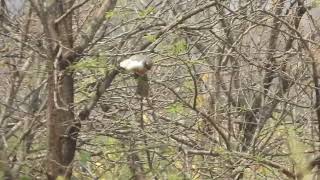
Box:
[47,1,76,179]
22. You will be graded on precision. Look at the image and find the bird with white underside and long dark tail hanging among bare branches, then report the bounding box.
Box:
[120,54,153,97]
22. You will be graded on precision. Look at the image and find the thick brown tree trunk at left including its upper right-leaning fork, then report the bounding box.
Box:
[43,0,116,180]
